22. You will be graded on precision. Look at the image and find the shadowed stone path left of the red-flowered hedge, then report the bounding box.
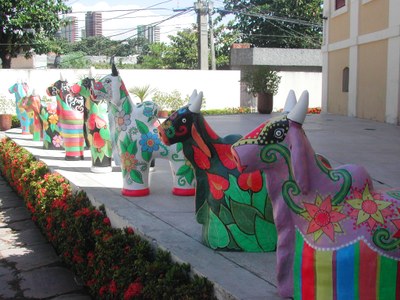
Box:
[0,170,91,300]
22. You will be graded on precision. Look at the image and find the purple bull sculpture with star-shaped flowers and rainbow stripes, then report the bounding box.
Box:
[232,91,400,300]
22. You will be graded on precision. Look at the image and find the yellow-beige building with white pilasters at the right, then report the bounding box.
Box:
[322,0,400,125]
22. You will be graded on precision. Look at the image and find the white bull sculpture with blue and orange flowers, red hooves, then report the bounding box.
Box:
[95,65,195,197]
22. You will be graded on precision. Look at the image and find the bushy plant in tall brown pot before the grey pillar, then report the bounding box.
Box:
[241,66,281,114]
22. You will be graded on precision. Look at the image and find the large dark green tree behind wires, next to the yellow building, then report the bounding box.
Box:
[220,0,322,48]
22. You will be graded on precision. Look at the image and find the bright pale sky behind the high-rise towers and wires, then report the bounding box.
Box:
[66,0,228,42]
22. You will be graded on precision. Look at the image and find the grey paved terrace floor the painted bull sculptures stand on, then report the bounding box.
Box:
[0,114,400,299]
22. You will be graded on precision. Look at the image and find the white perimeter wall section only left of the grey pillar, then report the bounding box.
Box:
[0,69,240,109]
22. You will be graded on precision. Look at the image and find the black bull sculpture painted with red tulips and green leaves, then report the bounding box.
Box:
[159,91,276,252]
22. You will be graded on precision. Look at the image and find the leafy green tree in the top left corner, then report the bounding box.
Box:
[0,0,70,69]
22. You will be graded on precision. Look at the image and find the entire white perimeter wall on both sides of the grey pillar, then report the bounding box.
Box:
[0,69,322,111]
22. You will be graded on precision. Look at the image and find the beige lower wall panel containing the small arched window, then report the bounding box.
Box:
[328,49,349,115]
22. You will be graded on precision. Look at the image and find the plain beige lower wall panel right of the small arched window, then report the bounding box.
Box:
[357,40,387,122]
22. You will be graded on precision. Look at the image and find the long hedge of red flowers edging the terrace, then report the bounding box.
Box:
[0,138,215,299]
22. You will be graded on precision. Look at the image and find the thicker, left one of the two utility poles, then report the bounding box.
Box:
[195,0,208,70]
